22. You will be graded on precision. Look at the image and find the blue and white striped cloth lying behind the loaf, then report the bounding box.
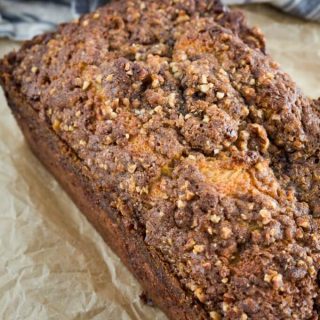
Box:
[0,0,320,40]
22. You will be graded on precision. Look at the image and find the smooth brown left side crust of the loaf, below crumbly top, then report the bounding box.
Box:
[5,80,207,320]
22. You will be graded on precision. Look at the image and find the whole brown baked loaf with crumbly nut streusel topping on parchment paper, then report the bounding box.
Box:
[0,0,320,320]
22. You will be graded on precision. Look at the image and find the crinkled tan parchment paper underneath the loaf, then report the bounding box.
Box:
[0,6,320,320]
